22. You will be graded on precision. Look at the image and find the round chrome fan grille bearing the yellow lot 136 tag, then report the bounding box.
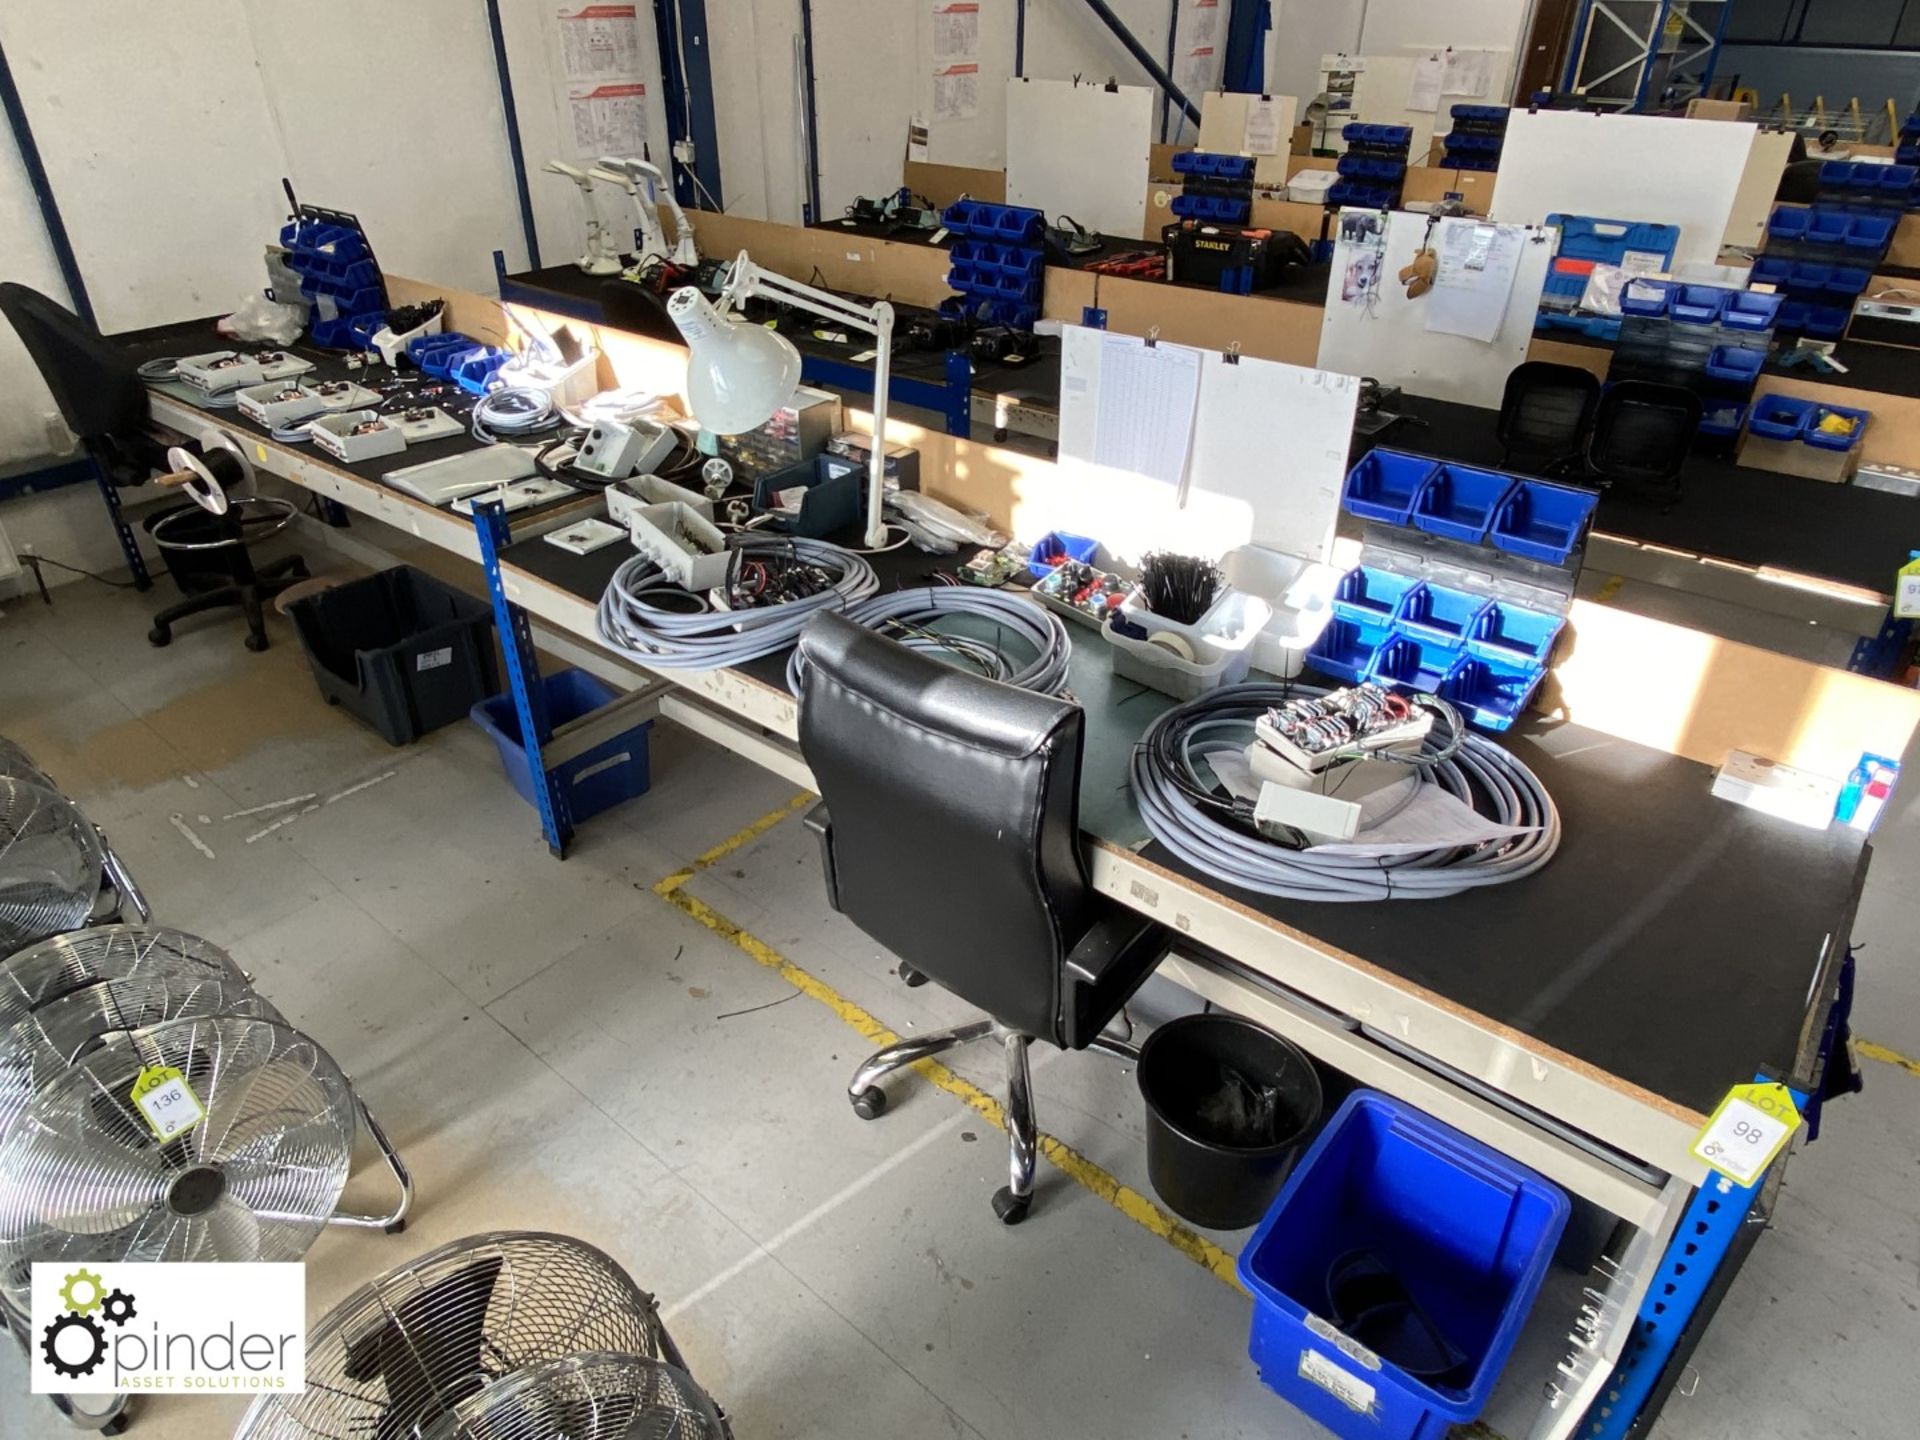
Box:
[0,1018,357,1309]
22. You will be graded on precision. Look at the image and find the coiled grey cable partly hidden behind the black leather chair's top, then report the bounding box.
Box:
[787,586,1073,695]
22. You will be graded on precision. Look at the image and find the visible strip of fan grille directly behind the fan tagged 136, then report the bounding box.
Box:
[0,966,280,1135]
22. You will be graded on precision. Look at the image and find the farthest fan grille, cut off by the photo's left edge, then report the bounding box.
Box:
[0,780,106,954]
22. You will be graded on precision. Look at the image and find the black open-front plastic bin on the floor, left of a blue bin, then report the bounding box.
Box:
[288,564,499,745]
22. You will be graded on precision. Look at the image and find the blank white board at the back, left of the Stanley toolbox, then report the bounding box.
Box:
[1006,81,1154,234]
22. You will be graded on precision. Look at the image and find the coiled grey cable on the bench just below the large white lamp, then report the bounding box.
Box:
[595,536,879,670]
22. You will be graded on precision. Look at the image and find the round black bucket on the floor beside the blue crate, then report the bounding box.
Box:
[1139,1014,1321,1231]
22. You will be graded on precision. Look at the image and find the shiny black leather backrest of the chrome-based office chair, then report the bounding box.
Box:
[801,614,1092,1043]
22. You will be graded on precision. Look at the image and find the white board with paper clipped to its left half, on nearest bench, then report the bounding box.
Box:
[1052,324,1359,561]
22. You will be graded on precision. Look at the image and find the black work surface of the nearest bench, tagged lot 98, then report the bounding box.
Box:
[503,540,1868,1116]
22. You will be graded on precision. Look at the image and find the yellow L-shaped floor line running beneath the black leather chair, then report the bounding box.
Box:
[653,795,1240,1290]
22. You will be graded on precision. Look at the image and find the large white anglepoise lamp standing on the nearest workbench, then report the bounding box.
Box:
[666,250,893,549]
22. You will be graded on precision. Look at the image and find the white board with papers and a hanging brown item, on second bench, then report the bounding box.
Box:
[1319,208,1553,409]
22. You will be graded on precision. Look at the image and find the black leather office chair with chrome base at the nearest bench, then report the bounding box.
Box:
[801,614,1167,1225]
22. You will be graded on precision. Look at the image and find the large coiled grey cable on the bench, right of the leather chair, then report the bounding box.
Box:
[1129,684,1561,900]
